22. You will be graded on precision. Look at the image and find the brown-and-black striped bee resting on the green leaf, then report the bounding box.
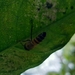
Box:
[24,32,46,50]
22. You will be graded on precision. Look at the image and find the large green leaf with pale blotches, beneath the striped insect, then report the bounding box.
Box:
[0,0,75,75]
